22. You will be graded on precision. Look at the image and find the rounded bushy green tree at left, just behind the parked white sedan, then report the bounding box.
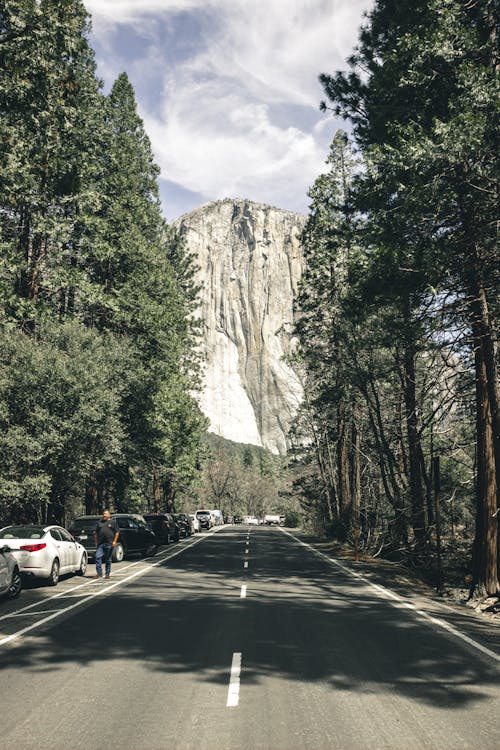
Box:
[0,321,126,520]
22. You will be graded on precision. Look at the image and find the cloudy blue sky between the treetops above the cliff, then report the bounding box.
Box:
[84,0,372,221]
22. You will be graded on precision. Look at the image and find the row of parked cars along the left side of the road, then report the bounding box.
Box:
[0,513,215,598]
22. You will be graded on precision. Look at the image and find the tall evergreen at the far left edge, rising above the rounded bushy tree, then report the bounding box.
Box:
[0,0,101,330]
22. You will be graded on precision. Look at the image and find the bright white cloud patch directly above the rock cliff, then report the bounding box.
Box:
[145,74,324,208]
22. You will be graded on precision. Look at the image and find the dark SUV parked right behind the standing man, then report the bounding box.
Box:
[69,513,158,562]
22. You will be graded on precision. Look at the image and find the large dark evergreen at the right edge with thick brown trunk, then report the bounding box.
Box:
[322,0,500,592]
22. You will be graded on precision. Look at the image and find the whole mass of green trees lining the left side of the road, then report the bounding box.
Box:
[0,0,206,520]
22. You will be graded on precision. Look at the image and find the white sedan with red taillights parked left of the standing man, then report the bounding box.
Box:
[0,525,87,586]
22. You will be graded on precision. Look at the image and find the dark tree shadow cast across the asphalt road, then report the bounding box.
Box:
[0,530,498,709]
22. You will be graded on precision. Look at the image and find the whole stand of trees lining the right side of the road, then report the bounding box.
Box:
[296,0,494,590]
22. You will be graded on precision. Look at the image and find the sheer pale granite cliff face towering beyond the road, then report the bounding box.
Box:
[175,199,305,454]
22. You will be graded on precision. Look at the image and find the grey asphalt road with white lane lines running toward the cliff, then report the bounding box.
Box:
[0,526,500,750]
